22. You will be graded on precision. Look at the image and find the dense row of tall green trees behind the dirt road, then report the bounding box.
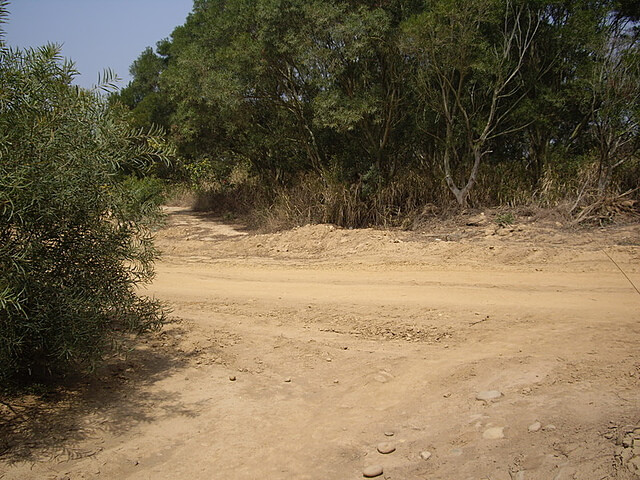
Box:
[120,0,640,224]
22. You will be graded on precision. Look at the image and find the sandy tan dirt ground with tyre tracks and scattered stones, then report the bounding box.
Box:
[0,208,640,480]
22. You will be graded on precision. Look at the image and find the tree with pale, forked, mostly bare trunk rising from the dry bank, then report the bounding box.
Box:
[404,0,539,207]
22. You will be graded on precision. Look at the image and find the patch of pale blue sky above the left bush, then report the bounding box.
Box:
[4,0,193,88]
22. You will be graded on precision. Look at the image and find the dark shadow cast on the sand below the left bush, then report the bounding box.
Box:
[0,326,197,464]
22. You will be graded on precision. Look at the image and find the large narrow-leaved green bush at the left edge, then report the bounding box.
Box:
[0,6,171,383]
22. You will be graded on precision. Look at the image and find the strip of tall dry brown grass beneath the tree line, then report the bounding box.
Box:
[172,158,637,232]
